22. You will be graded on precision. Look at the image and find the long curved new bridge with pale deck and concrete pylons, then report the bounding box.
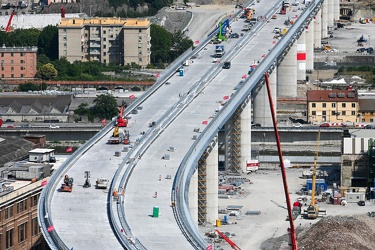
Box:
[38,0,338,250]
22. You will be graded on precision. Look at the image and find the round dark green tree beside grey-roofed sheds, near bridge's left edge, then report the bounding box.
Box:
[93,94,118,119]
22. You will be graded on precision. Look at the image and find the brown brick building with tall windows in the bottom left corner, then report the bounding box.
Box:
[0,180,49,250]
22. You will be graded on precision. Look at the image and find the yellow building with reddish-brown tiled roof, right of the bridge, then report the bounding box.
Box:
[307,90,359,123]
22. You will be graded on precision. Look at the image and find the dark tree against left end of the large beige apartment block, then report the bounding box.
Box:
[38,25,59,61]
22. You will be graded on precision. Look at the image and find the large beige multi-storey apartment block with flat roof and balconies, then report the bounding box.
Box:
[58,18,151,67]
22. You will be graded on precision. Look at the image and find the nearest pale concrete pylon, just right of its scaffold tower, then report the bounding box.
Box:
[206,143,219,225]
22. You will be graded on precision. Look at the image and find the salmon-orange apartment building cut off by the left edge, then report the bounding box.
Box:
[0,45,38,79]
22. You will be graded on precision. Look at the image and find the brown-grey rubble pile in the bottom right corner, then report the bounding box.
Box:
[297,215,375,250]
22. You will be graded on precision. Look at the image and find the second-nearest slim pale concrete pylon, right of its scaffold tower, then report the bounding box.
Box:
[240,97,254,173]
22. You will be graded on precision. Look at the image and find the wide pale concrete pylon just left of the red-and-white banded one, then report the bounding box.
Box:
[277,44,297,97]
